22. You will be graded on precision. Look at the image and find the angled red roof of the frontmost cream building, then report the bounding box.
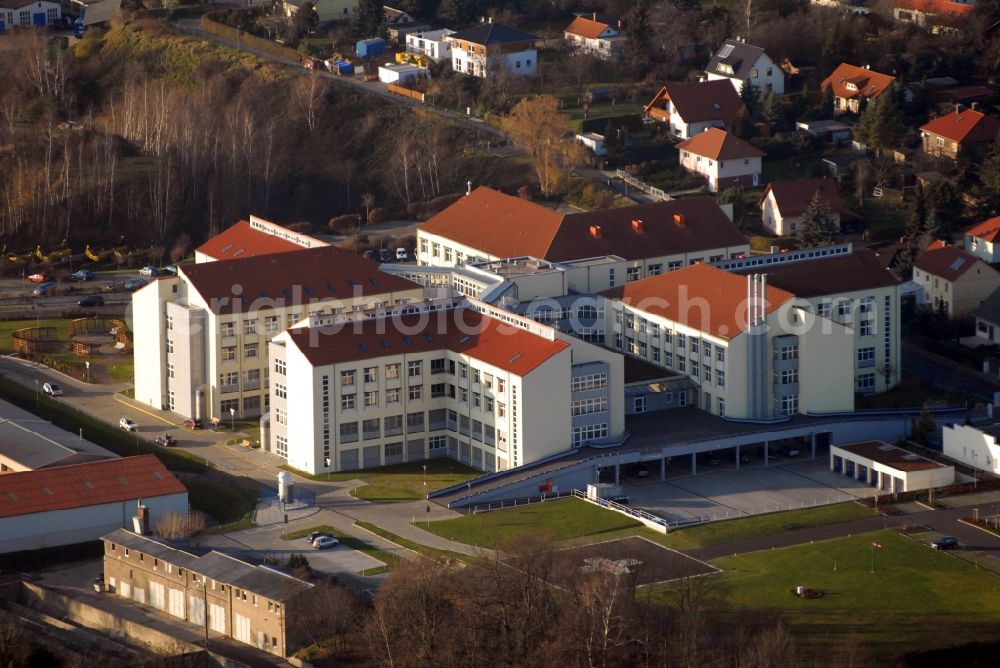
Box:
[287,307,569,376]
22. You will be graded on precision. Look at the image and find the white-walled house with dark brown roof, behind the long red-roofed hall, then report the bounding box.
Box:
[760,177,859,236]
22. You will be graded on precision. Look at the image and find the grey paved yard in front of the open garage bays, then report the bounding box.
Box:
[624,457,875,521]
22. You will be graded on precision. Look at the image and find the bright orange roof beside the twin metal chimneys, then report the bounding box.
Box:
[601,264,795,340]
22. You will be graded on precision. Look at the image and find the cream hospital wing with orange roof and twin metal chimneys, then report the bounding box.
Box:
[600,264,854,420]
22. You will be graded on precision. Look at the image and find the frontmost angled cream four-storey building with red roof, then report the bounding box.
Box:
[270,299,624,473]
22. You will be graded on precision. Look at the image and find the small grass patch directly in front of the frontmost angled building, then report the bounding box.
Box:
[281,458,483,503]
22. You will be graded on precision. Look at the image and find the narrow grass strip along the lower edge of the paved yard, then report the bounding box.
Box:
[665,502,874,550]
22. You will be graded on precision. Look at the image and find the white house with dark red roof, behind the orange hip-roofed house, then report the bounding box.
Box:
[645,80,743,139]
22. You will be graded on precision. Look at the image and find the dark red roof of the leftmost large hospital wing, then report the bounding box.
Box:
[178,246,420,313]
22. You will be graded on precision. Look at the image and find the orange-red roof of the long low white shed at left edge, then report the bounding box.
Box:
[0,455,187,517]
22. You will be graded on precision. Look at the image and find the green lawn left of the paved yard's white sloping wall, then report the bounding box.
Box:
[428,498,642,548]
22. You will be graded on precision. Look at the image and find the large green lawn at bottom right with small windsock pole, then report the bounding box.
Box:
[713,531,1000,665]
